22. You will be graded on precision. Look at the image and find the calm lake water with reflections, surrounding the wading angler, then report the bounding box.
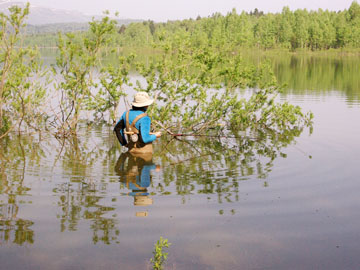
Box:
[0,53,360,270]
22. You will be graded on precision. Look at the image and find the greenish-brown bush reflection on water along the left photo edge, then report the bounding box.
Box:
[0,136,35,245]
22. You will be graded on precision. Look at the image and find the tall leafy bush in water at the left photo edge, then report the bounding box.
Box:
[0,4,45,137]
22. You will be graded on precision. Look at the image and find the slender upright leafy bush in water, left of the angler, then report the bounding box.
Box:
[53,14,116,135]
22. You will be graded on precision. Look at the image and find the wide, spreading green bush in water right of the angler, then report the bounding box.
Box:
[137,38,311,135]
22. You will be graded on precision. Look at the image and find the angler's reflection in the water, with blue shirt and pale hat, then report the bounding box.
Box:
[115,152,159,216]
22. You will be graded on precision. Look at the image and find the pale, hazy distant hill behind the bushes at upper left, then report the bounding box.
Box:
[0,0,139,26]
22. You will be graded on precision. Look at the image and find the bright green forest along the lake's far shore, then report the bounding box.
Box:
[25,1,360,51]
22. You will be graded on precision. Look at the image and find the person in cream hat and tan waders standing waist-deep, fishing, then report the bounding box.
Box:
[114,92,161,154]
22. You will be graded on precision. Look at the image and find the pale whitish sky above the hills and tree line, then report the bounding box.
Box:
[23,0,353,22]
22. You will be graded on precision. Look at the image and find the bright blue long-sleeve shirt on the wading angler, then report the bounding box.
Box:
[114,110,156,145]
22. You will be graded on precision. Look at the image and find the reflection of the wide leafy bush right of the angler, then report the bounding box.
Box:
[157,125,303,203]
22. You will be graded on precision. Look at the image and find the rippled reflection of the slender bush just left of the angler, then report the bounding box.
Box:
[53,126,120,244]
